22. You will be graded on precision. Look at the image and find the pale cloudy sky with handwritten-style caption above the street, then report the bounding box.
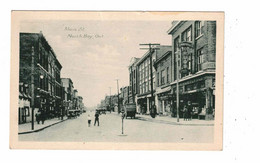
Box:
[20,20,171,107]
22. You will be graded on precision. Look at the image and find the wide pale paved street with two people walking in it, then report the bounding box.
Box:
[19,112,214,143]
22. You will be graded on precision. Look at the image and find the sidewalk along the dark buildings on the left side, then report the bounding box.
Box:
[18,117,68,134]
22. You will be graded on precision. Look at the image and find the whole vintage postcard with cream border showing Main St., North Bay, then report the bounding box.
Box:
[10,11,224,150]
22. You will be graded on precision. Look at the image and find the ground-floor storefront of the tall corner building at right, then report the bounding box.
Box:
[172,73,215,119]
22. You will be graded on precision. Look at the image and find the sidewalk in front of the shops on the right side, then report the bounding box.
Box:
[136,114,215,126]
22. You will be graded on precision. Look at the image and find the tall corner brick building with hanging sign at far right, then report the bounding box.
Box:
[168,21,216,119]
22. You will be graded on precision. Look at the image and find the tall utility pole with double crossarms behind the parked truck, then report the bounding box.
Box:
[139,43,160,118]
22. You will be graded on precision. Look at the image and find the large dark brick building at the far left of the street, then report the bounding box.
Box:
[19,32,62,122]
